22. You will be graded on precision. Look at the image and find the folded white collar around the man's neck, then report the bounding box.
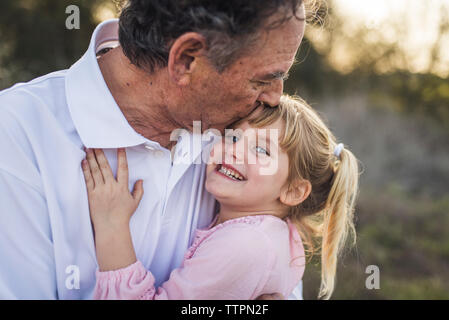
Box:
[65,19,147,148]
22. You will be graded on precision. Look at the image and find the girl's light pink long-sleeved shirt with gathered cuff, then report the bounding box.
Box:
[94,215,305,300]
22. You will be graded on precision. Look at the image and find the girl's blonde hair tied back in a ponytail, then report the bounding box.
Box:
[249,95,359,299]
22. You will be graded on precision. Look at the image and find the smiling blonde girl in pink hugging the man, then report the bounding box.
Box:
[82,96,358,299]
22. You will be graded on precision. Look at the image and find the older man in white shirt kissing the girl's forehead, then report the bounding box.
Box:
[0,0,305,299]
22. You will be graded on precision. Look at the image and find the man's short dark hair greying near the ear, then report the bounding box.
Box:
[119,0,304,73]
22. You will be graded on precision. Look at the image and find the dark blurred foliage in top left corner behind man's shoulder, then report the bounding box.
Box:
[0,0,112,89]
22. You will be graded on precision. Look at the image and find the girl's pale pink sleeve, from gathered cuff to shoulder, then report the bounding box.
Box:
[94,224,275,300]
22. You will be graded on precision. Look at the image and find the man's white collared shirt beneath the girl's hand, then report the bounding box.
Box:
[0,19,302,299]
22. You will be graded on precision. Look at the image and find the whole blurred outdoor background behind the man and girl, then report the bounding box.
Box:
[0,0,449,299]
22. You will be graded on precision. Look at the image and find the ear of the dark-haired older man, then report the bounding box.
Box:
[168,32,206,86]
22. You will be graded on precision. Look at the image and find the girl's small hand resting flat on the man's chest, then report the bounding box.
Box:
[82,148,143,232]
